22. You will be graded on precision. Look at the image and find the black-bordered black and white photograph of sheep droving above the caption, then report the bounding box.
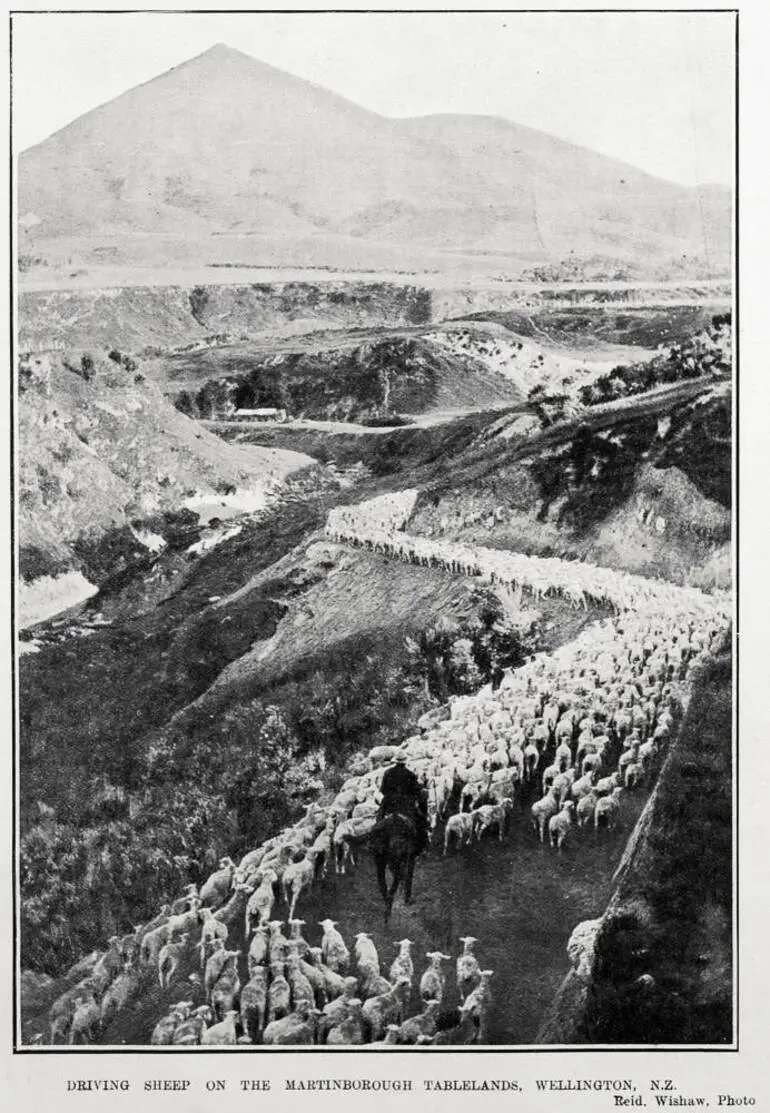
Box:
[7,10,738,1050]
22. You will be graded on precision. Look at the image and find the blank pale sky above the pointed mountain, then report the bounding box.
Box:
[12,11,734,185]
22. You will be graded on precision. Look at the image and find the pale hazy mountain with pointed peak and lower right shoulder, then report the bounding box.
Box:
[18,45,730,277]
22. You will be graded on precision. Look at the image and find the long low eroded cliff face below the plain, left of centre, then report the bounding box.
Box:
[19,282,432,352]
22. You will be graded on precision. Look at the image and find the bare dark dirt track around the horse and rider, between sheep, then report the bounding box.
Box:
[93,795,643,1045]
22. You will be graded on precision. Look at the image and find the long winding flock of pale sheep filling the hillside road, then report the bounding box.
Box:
[40,492,729,1046]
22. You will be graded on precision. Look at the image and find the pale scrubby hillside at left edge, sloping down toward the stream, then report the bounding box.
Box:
[17,353,310,579]
